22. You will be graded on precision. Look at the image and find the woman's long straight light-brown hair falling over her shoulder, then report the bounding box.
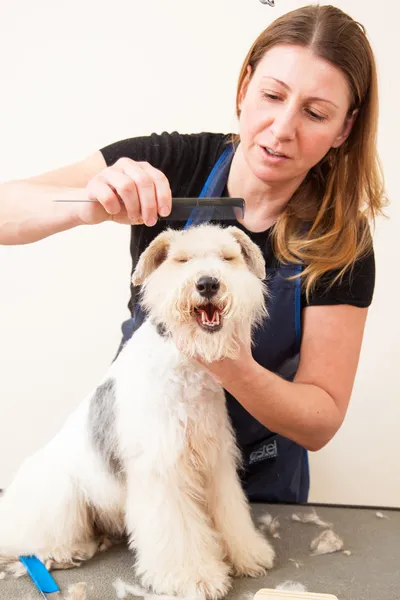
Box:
[236,5,386,295]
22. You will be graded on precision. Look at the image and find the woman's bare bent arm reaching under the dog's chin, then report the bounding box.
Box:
[200,305,368,451]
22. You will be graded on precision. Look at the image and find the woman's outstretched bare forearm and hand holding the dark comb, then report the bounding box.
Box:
[0,150,172,244]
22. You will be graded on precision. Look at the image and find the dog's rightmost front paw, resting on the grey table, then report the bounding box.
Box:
[229,536,275,577]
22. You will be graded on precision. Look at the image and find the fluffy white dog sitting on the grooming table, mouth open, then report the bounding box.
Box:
[0,225,274,598]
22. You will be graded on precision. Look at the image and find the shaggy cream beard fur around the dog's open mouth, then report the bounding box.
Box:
[139,274,266,362]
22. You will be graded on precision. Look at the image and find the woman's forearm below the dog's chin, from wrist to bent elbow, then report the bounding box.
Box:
[222,362,342,451]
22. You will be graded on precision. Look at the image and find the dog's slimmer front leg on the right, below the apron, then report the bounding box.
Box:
[211,436,275,577]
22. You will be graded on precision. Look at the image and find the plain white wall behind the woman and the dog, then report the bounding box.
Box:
[0,0,400,506]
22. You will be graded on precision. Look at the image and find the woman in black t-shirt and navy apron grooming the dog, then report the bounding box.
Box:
[0,6,383,502]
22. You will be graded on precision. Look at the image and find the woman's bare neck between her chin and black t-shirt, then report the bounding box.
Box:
[227,144,299,232]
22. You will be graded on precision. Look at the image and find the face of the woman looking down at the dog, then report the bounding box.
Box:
[239,44,353,184]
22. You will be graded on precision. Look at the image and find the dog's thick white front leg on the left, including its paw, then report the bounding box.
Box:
[126,466,231,599]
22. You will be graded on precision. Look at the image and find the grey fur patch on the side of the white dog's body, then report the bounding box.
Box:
[89,379,122,475]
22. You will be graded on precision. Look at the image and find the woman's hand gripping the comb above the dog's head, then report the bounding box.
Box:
[79,158,172,227]
